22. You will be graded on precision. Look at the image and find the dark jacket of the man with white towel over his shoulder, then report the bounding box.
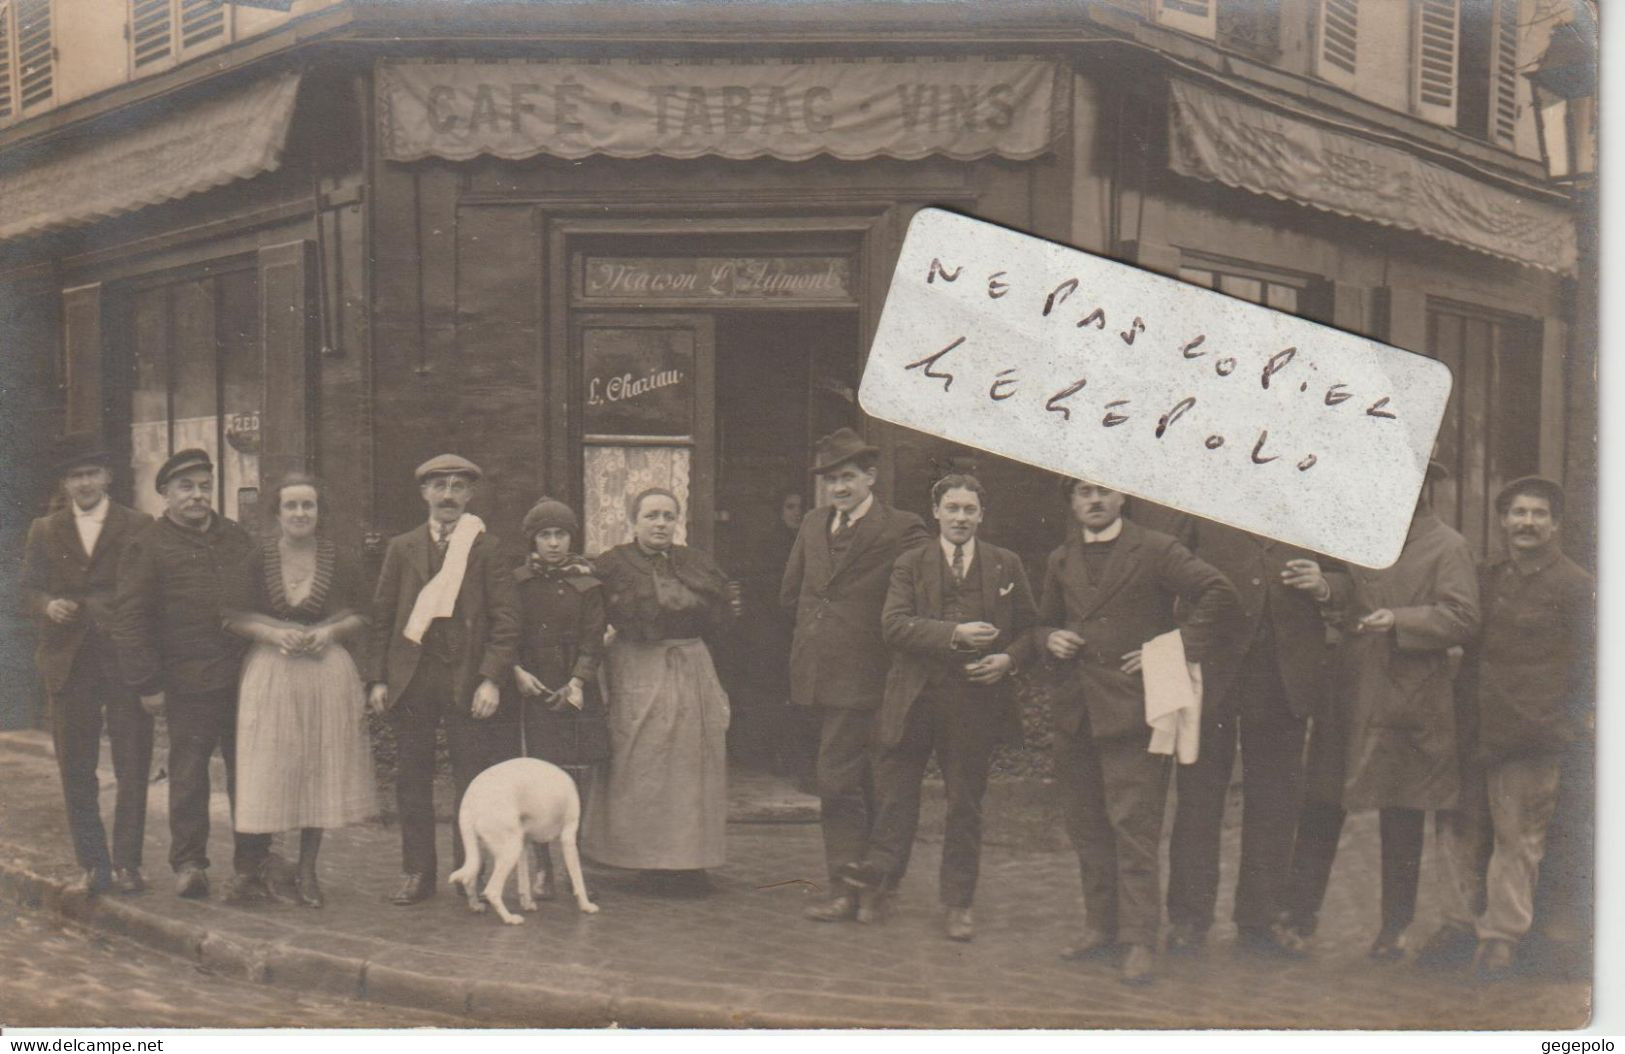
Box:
[366,523,518,708]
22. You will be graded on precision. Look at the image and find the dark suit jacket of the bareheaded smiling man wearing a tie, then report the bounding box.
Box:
[881,538,1038,747]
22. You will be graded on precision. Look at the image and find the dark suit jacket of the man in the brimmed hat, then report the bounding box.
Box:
[778,499,931,710]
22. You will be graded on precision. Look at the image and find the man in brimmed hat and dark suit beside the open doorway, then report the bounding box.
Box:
[778,429,931,922]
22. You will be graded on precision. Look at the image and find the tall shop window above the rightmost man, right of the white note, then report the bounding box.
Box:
[1427,302,1541,554]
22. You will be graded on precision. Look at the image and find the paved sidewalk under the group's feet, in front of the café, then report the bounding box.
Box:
[0,732,1591,1030]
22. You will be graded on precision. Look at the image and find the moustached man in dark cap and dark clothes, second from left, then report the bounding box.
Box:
[114,448,271,900]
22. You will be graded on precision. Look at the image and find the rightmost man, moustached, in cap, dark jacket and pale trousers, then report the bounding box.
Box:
[1428,476,1596,976]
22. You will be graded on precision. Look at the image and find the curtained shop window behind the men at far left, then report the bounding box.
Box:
[128,270,265,520]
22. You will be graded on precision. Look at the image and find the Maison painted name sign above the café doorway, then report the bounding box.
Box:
[582,257,852,300]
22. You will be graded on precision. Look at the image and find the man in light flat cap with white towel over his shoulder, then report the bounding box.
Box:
[366,453,520,905]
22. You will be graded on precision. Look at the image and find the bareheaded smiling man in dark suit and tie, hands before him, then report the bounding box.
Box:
[842,474,1037,940]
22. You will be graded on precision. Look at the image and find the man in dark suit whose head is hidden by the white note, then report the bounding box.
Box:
[1168,516,1349,952]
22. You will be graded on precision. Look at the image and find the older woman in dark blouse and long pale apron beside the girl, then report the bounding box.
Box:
[582,489,733,896]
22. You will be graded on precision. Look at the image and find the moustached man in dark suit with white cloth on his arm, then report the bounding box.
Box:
[1019,479,1235,984]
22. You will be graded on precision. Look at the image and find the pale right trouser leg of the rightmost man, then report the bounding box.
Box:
[1477,757,1562,940]
